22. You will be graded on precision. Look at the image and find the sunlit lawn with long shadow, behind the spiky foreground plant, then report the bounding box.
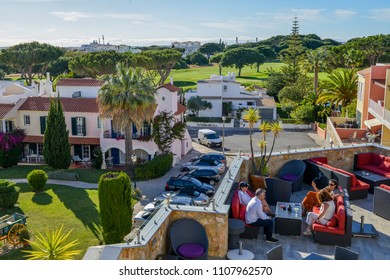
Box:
[0,184,102,260]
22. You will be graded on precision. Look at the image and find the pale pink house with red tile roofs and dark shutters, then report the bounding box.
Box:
[0,75,192,164]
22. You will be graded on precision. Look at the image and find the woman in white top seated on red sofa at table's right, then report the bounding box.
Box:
[303,189,336,235]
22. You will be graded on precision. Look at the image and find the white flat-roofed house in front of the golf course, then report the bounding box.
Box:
[185,73,277,120]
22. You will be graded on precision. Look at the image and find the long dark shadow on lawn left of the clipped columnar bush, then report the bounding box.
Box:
[52,185,102,242]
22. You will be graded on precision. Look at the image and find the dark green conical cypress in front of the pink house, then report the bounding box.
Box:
[43,96,71,169]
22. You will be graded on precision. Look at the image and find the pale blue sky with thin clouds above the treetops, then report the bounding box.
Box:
[0,0,390,47]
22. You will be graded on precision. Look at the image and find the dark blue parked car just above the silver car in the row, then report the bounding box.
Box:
[165,176,216,196]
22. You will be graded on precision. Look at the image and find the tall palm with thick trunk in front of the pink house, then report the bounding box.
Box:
[98,64,156,177]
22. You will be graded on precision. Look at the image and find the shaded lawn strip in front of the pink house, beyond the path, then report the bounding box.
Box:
[0,165,108,183]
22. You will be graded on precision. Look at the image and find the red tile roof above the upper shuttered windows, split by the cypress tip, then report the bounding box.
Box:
[19,97,99,113]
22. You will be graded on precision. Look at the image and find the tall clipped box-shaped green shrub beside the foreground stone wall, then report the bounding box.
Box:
[98,172,133,244]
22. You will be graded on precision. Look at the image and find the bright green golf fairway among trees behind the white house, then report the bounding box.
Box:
[166,62,283,89]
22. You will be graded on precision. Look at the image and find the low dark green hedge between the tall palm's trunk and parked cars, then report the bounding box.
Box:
[135,154,173,180]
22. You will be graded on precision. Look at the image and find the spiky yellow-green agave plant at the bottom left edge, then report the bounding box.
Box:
[22,225,81,260]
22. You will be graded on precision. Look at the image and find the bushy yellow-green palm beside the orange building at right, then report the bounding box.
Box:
[317,69,358,110]
